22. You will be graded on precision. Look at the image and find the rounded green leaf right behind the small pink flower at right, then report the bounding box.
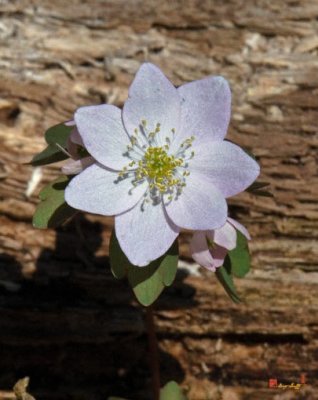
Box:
[228,231,251,278]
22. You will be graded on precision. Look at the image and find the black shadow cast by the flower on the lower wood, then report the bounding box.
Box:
[0,215,195,400]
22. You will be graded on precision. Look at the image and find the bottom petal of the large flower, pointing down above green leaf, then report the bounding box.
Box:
[115,200,180,267]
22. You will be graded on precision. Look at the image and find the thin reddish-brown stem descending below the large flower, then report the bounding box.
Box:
[146,306,160,400]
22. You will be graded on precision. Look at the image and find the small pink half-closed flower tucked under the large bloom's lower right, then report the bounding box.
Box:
[190,218,251,272]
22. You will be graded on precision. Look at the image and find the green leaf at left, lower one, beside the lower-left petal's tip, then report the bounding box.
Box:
[33,175,77,229]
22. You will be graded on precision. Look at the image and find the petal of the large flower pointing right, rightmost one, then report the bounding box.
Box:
[189,141,260,198]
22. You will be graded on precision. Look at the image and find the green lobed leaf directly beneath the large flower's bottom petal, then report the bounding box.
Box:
[109,231,179,306]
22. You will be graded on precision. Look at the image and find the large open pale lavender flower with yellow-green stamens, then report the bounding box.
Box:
[65,63,259,266]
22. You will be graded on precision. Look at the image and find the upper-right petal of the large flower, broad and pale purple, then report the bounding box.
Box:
[172,76,231,153]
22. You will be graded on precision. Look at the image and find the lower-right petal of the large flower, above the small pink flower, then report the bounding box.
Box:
[165,171,227,230]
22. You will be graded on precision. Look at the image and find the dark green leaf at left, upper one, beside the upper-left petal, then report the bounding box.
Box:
[31,124,74,166]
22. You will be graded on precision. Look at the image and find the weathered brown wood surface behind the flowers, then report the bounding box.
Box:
[0,0,318,400]
